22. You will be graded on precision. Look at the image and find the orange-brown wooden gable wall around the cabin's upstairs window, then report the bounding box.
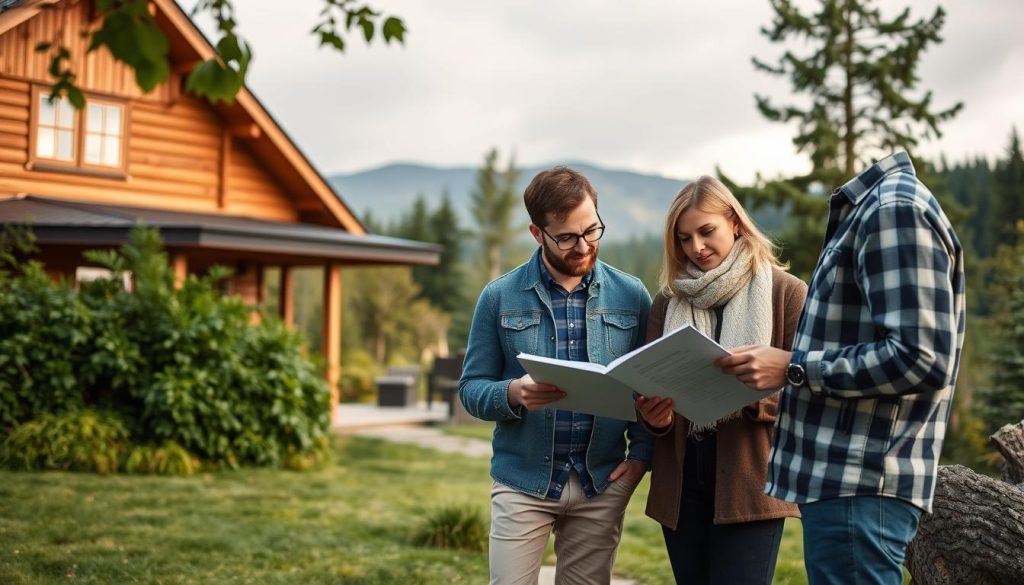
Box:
[0,2,299,221]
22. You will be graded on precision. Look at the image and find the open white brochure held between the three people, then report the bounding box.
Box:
[517,325,768,424]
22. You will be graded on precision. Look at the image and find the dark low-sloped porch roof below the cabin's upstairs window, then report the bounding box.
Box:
[0,195,440,264]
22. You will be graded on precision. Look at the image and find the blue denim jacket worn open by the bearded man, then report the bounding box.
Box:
[459,248,653,498]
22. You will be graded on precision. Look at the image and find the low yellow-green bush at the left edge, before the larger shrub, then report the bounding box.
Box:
[0,410,128,473]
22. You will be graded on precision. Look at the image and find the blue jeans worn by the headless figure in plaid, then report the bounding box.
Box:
[800,496,922,585]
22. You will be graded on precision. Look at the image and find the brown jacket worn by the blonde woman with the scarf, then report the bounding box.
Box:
[647,268,807,530]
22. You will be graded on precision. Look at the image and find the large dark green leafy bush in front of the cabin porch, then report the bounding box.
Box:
[0,227,330,467]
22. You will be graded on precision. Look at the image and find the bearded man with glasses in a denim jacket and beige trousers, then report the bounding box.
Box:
[459,167,652,584]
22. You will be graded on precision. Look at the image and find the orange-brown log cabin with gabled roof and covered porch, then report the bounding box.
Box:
[0,0,439,422]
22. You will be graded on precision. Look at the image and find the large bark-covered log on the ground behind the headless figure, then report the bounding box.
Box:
[906,467,1024,585]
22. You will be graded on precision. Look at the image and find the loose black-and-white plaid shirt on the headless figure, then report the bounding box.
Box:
[765,153,965,511]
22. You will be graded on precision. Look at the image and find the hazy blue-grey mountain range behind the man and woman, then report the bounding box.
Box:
[328,162,780,241]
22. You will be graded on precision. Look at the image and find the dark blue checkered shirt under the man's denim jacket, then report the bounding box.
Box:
[537,254,597,500]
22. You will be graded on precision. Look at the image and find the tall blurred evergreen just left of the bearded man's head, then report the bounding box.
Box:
[470,149,519,280]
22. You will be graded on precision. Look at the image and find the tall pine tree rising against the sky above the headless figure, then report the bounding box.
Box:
[753,0,963,187]
